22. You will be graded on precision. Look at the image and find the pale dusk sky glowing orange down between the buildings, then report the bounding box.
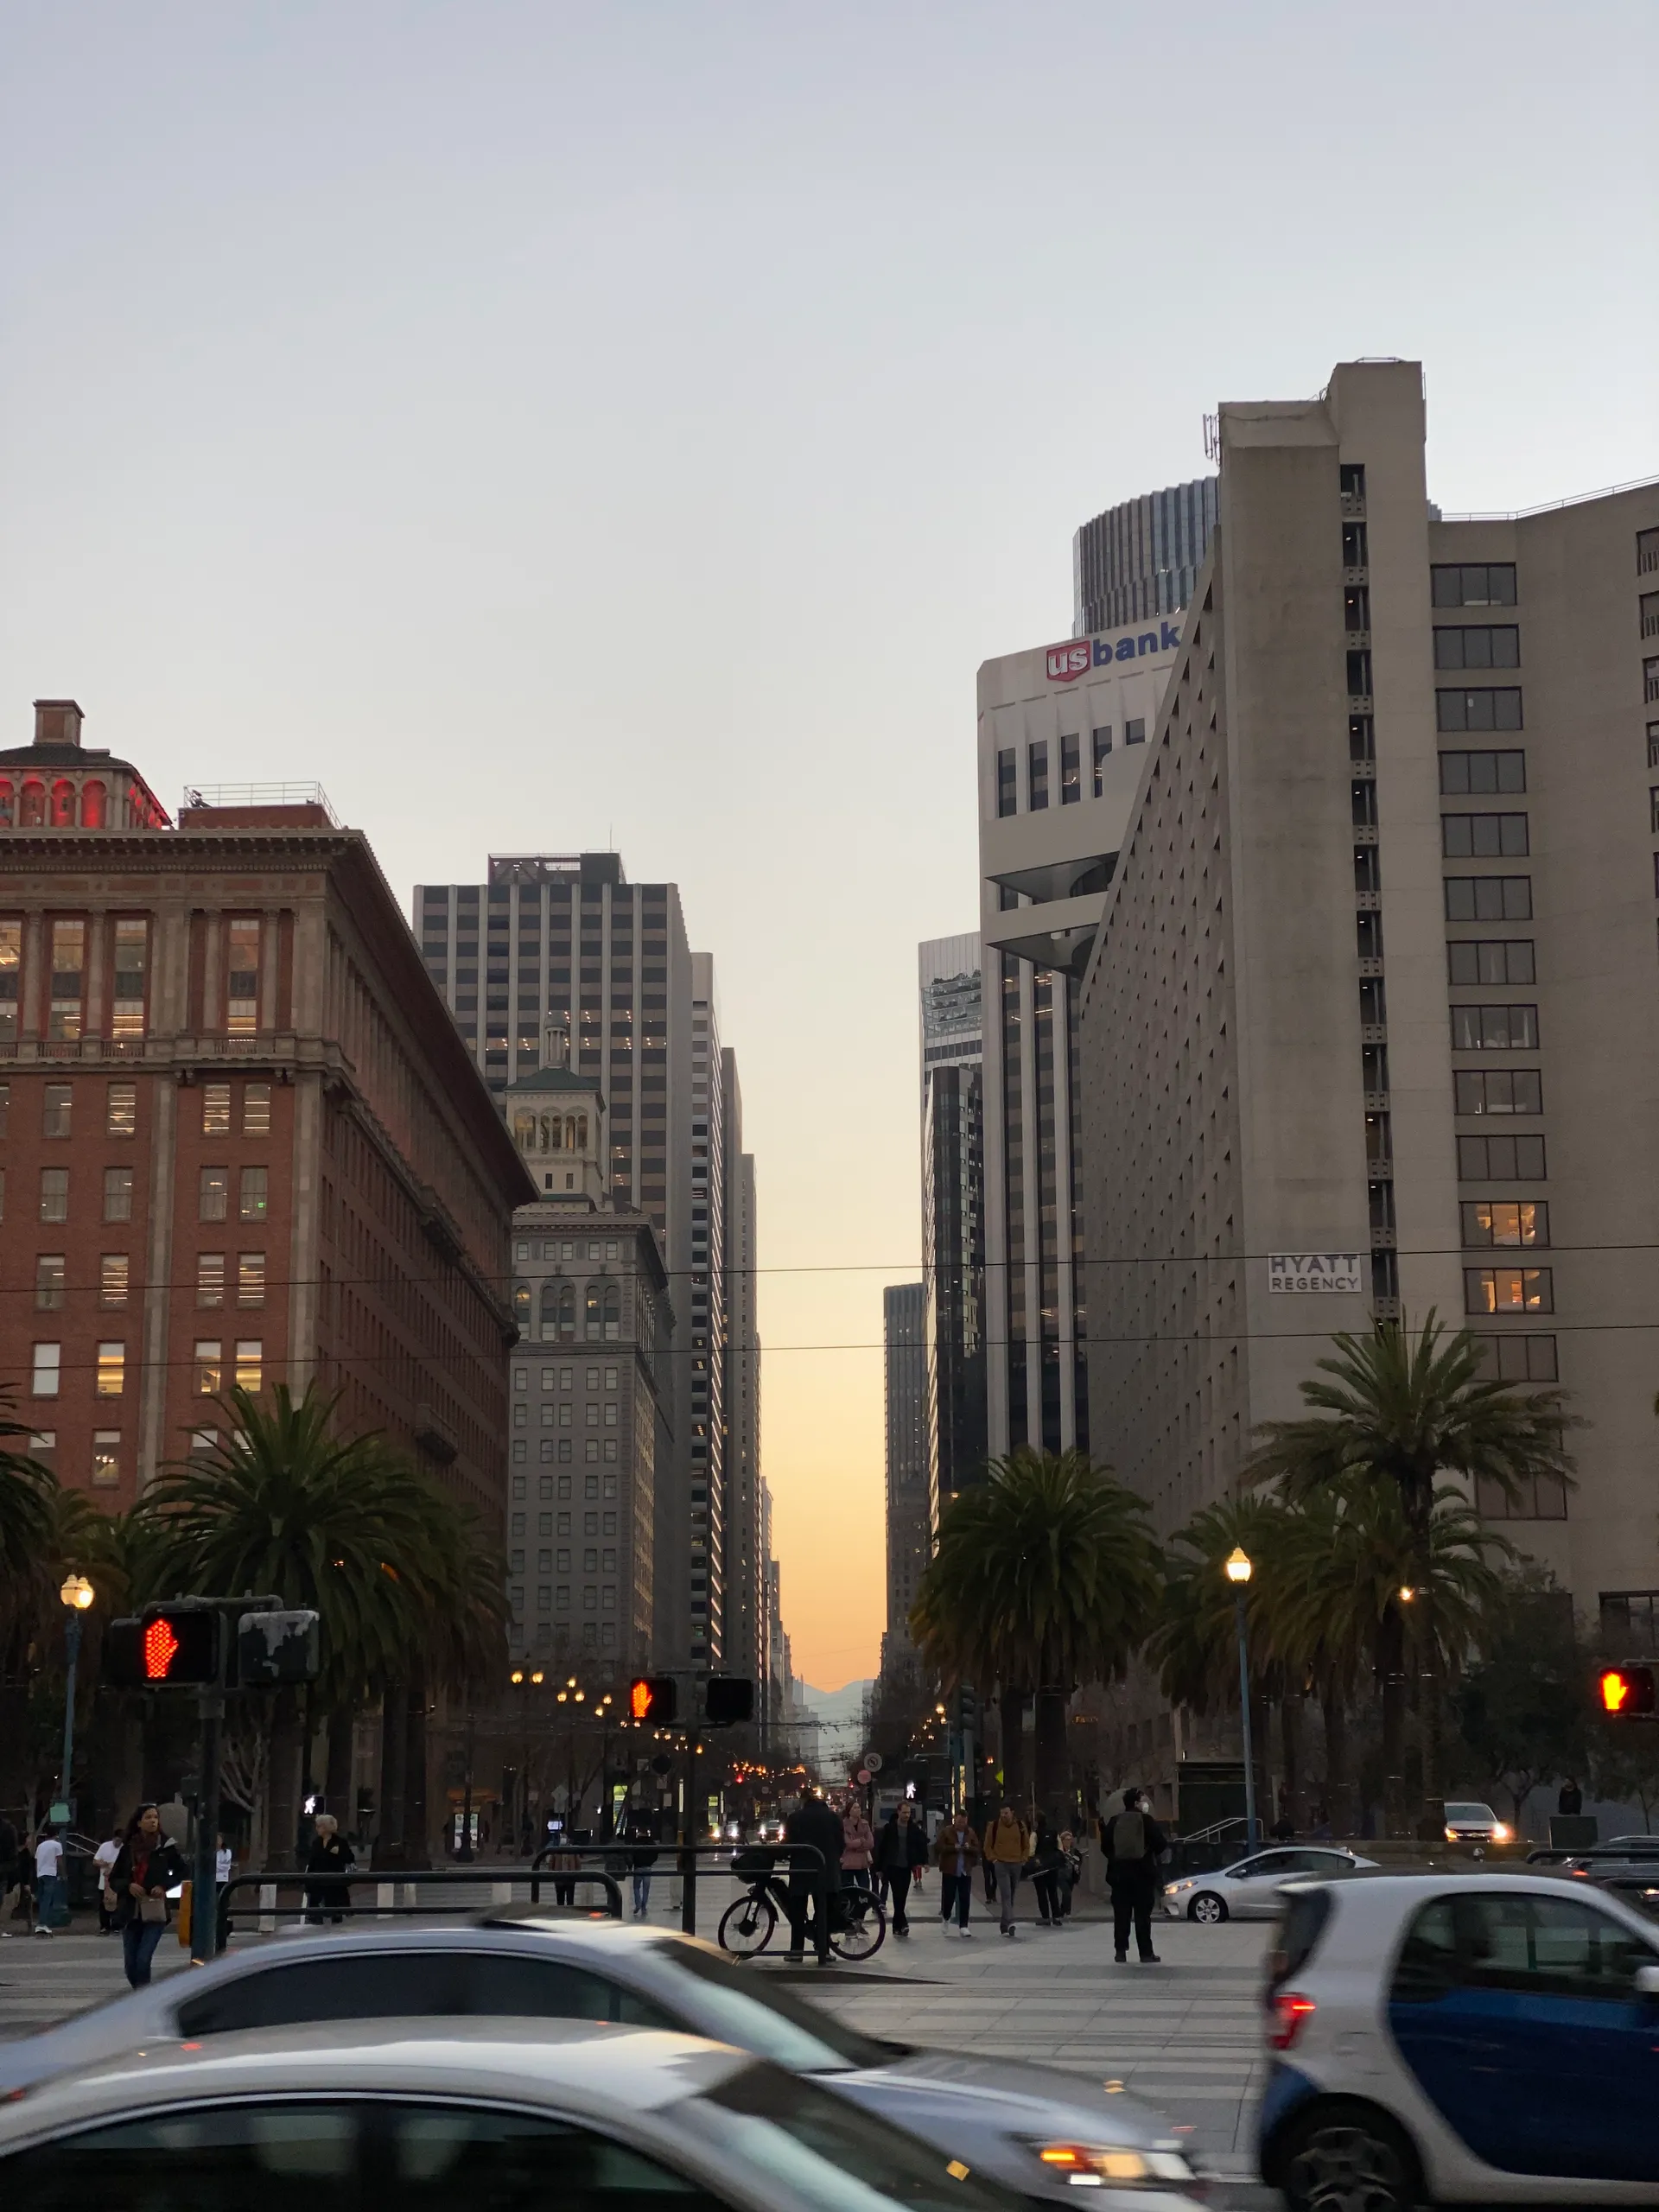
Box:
[0,0,1659,1688]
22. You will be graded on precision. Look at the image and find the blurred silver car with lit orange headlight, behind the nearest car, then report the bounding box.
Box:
[0,1907,1192,2201]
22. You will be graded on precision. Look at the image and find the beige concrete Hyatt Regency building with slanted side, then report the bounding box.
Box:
[1079,360,1659,1654]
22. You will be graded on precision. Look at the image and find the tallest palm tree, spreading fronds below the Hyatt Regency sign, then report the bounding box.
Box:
[1248,1307,1577,1827]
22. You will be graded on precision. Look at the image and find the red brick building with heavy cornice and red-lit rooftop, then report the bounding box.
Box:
[0,702,536,1533]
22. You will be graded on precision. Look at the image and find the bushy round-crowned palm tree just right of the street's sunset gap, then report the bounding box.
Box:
[912,1446,1159,1814]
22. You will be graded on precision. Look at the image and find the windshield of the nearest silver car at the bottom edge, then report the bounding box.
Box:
[672,2066,1024,2212]
